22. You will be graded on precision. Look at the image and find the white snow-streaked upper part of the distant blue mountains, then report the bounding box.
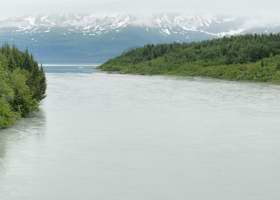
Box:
[0,14,245,36]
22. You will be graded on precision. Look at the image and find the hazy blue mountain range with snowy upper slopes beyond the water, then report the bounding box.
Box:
[0,14,280,63]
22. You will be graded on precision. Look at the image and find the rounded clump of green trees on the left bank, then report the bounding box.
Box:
[0,45,46,128]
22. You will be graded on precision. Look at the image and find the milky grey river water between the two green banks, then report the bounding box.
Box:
[0,68,280,200]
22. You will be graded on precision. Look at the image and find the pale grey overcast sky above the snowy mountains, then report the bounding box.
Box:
[0,0,280,18]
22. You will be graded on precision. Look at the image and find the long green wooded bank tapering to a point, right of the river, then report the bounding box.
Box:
[99,34,280,84]
